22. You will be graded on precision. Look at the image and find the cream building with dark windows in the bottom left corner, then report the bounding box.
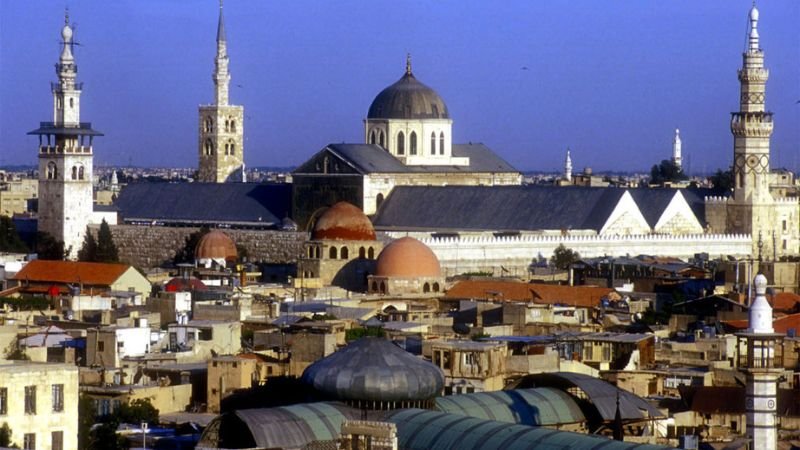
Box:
[0,360,78,450]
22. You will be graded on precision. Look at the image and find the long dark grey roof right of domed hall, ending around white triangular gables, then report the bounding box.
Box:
[373,185,704,231]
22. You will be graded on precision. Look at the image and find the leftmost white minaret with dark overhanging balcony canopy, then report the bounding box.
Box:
[28,11,102,258]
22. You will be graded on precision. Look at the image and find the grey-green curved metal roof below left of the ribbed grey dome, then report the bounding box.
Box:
[235,403,360,448]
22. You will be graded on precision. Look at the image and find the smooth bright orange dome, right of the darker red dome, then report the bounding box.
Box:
[375,237,442,277]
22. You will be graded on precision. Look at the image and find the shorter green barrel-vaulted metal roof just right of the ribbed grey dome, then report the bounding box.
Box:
[436,388,586,426]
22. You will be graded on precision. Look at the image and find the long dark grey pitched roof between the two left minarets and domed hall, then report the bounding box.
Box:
[115,183,292,228]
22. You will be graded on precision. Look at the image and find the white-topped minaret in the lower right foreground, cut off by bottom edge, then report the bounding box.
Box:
[736,274,784,450]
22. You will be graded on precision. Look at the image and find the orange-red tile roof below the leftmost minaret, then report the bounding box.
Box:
[12,260,131,286]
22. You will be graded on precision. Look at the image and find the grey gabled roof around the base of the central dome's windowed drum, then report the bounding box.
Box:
[294,143,517,175]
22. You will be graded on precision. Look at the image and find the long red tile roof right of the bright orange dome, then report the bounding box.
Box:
[444,280,619,308]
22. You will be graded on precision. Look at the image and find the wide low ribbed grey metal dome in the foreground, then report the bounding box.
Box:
[302,337,444,402]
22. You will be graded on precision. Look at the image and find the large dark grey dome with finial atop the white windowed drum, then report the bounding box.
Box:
[367,70,450,119]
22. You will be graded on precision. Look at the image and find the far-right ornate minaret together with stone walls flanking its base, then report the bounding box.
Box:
[706,6,800,260]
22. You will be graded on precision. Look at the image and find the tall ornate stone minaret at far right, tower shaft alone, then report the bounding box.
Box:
[727,5,776,255]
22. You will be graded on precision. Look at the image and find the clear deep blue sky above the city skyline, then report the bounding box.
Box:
[0,0,800,172]
